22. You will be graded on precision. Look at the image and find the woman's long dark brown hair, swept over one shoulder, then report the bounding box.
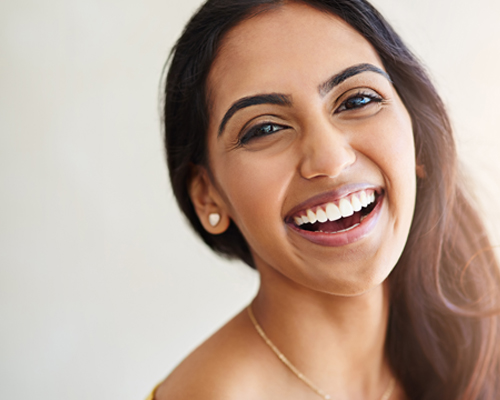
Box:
[164,0,500,400]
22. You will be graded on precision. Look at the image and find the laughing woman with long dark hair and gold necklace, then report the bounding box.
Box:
[152,0,500,400]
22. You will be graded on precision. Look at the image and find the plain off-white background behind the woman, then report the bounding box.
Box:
[0,0,500,400]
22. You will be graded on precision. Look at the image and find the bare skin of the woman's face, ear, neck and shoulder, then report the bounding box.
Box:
[157,3,416,400]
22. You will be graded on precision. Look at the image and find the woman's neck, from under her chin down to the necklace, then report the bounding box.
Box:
[253,260,391,399]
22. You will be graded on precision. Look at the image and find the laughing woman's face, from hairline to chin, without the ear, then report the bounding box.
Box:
[204,3,416,295]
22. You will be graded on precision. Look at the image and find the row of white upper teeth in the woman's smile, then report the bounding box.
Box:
[294,189,375,226]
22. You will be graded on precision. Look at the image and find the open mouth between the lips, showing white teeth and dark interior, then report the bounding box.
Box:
[292,189,382,234]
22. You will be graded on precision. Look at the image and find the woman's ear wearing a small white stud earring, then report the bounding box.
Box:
[189,165,231,235]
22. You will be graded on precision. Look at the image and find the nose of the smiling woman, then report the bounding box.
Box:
[299,117,356,179]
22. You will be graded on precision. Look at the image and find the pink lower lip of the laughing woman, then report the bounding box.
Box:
[287,195,384,247]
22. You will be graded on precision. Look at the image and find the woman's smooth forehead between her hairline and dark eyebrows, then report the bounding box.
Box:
[208,3,383,123]
